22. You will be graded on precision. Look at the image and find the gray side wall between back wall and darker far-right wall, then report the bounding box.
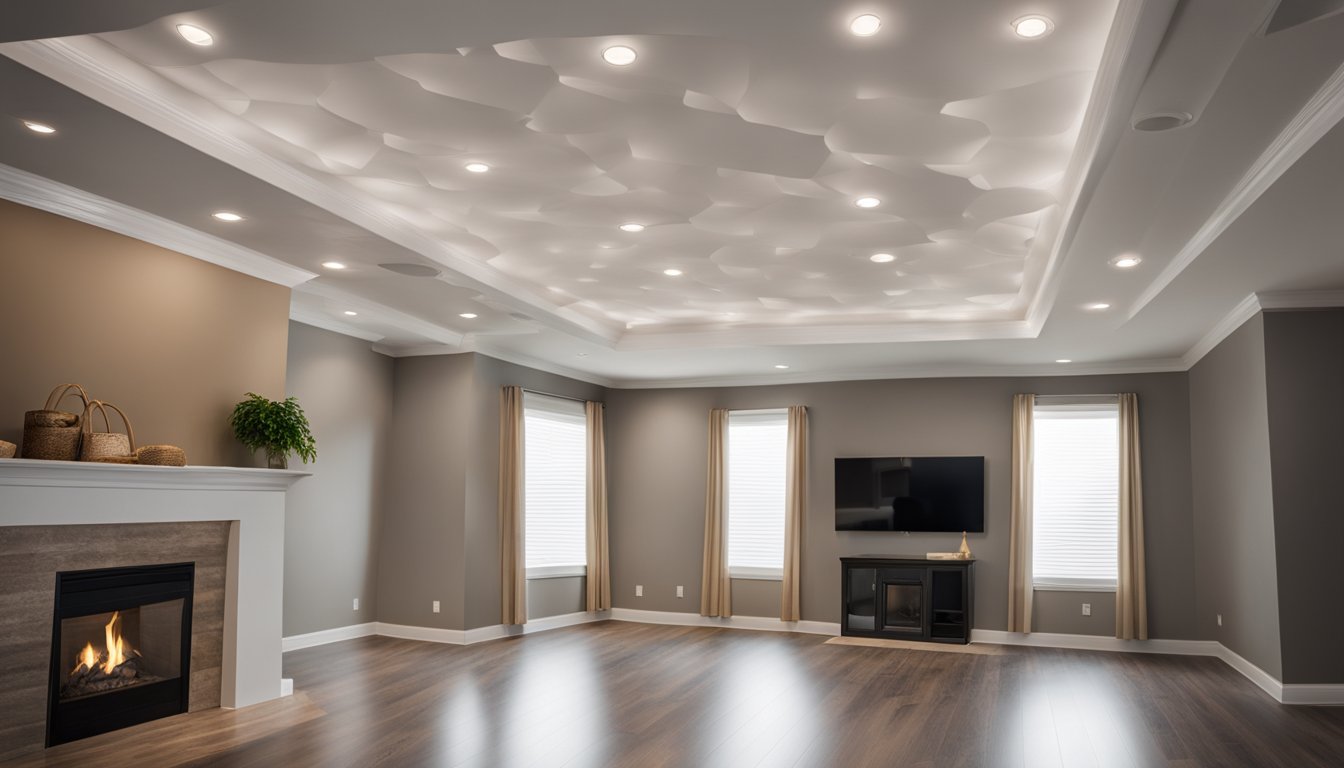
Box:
[1188,315,1284,679]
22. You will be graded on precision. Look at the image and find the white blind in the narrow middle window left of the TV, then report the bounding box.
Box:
[724,409,789,580]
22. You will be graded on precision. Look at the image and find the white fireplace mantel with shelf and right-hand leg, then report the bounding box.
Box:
[0,459,308,707]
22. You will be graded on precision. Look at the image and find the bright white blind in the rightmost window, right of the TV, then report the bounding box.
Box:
[1032,402,1120,590]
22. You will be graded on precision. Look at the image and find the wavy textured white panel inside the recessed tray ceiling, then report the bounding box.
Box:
[94,0,1114,332]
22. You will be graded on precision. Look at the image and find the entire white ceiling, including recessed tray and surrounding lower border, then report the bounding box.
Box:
[0,0,1344,383]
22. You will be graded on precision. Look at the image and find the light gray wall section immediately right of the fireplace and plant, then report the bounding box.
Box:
[284,323,392,636]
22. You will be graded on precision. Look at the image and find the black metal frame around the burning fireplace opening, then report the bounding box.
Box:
[47,562,196,746]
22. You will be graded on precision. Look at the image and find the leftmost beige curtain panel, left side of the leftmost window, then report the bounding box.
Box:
[500,386,527,624]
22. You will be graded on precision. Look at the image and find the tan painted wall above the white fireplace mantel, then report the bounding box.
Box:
[0,200,289,465]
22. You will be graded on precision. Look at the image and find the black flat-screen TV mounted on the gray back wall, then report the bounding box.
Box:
[836,456,985,533]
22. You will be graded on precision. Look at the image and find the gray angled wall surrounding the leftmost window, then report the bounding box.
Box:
[378,352,606,629]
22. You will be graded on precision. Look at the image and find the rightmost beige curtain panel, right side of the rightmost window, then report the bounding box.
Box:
[1116,393,1148,640]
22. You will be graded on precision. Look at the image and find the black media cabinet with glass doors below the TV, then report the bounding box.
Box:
[840,554,976,643]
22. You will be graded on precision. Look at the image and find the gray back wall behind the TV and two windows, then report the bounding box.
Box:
[607,374,1198,639]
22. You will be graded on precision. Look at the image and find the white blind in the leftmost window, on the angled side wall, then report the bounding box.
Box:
[523,391,587,578]
